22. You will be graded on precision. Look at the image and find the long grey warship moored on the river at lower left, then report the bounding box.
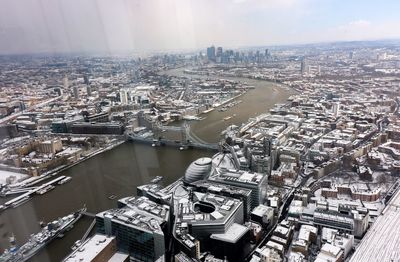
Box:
[0,208,86,262]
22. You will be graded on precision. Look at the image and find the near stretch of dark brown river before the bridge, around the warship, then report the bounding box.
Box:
[0,142,213,262]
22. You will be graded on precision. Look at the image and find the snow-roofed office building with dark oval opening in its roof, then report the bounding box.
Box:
[173,189,250,261]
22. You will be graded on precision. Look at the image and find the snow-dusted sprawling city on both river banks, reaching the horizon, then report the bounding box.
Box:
[0,41,400,262]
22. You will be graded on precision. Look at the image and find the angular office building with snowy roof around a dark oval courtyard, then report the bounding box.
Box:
[173,188,246,259]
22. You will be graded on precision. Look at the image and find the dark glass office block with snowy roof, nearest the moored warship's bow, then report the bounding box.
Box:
[96,197,169,262]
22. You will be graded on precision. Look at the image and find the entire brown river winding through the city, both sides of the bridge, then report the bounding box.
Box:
[0,70,293,262]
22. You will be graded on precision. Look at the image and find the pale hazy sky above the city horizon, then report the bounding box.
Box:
[0,0,400,53]
